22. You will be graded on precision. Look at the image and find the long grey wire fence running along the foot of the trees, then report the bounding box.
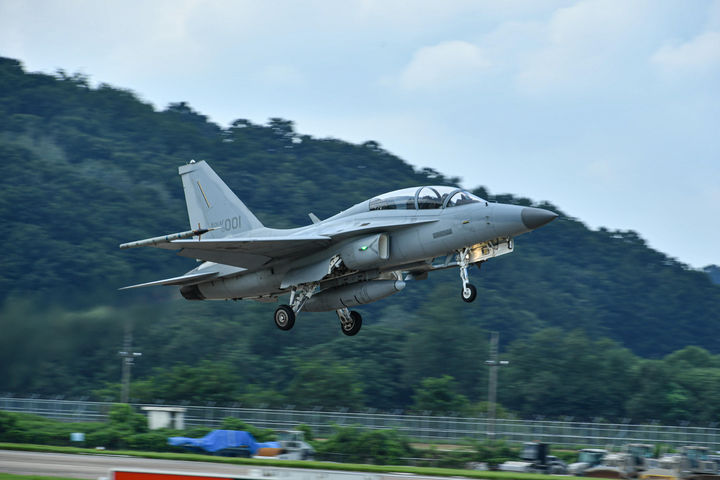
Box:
[0,397,720,450]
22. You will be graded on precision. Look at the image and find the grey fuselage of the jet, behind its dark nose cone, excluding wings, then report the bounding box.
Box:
[186,193,531,300]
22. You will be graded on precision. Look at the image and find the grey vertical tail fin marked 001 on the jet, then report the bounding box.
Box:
[178,160,263,238]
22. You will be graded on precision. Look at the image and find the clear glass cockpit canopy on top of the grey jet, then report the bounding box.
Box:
[370,186,485,210]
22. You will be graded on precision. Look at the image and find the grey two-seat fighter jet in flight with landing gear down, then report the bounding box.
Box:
[120,161,557,336]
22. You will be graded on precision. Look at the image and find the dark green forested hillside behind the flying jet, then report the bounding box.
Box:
[0,59,720,421]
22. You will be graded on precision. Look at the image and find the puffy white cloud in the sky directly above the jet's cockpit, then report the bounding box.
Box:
[398,40,491,90]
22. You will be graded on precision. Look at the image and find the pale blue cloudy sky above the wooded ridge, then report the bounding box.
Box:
[0,0,720,268]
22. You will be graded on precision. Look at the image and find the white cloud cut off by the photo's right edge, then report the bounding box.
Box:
[650,32,720,73]
